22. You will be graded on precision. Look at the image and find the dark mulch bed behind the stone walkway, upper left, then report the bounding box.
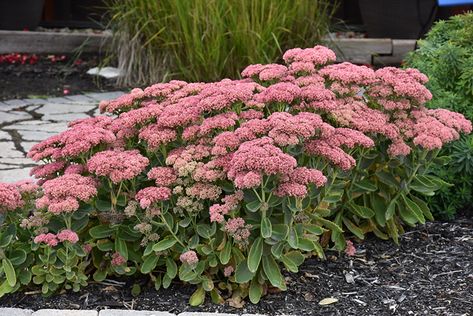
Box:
[0,54,118,100]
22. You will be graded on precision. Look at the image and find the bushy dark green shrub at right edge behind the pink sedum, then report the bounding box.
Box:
[406,13,473,219]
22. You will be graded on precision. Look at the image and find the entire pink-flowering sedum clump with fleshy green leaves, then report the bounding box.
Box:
[0,46,472,305]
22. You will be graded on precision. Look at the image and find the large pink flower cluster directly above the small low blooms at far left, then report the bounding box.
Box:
[36,174,97,213]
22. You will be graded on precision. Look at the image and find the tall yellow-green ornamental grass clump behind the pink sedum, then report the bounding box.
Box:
[109,0,334,85]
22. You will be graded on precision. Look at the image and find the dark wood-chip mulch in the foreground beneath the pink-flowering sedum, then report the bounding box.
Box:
[0,217,473,316]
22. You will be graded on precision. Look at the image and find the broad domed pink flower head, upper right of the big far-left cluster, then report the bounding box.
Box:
[87,150,149,183]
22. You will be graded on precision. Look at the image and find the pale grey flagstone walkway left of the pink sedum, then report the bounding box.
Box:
[0,91,123,182]
